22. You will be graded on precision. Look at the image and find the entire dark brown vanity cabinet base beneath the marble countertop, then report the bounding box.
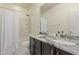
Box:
[30,37,72,55]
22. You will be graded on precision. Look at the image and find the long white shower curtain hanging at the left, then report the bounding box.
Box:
[0,8,21,54]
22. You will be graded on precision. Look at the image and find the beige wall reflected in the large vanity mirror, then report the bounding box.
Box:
[42,3,79,32]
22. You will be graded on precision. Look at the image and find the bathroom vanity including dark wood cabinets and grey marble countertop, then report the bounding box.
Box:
[30,35,79,55]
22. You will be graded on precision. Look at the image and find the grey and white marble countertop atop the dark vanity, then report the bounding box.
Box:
[30,35,79,55]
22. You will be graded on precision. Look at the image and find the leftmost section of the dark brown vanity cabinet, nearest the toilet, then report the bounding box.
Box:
[30,37,42,55]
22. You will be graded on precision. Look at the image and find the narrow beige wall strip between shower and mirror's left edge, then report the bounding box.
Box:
[29,3,43,34]
